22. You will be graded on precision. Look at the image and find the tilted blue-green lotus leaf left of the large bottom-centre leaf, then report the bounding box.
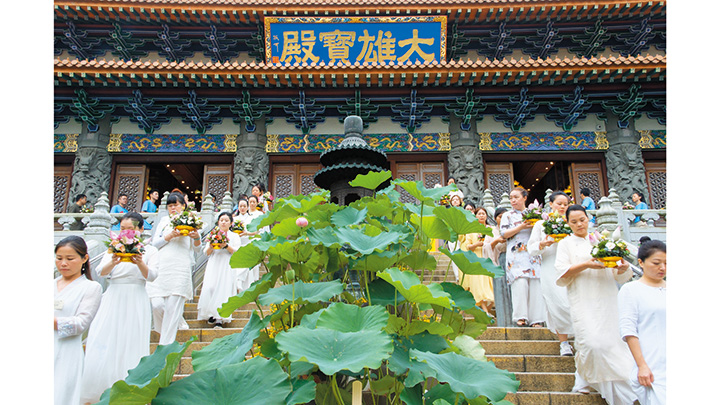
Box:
[192,311,270,372]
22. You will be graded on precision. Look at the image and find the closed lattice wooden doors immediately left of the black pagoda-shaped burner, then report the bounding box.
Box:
[269,163,322,199]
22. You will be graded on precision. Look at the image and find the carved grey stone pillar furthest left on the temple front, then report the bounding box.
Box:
[70,115,112,205]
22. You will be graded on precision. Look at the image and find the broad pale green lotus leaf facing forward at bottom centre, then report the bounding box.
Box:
[275,326,393,375]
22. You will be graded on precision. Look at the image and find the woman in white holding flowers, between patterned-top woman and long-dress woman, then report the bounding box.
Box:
[528,191,587,380]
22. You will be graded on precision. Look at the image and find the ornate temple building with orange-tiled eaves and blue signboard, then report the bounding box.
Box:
[53,0,667,212]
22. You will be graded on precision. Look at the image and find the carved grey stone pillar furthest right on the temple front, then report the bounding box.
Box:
[605,111,648,201]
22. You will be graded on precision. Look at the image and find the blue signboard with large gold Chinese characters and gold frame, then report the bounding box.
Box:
[265,16,447,65]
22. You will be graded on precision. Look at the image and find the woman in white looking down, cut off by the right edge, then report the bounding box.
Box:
[618,236,667,405]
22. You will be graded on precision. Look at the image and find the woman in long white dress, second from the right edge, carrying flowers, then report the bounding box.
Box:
[555,205,637,405]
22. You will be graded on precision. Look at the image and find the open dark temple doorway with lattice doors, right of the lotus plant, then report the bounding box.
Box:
[483,153,607,205]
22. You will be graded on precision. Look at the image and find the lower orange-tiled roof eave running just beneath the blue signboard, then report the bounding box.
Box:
[55,55,667,87]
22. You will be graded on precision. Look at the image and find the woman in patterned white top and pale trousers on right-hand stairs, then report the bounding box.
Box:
[500,187,547,327]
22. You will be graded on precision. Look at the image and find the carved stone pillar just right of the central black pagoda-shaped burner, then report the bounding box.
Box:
[448,114,485,205]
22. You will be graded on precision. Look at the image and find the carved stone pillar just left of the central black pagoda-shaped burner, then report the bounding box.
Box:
[233,118,270,201]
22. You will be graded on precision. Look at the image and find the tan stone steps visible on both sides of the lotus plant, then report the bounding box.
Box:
[150,256,605,405]
